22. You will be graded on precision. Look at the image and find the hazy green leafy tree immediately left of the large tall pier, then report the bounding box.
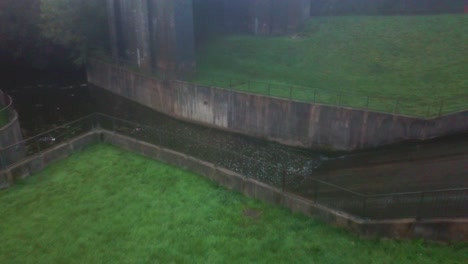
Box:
[40,0,108,65]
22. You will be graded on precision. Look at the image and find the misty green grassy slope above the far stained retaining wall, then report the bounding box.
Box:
[196,15,468,116]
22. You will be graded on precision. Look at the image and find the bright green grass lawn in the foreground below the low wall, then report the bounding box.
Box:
[0,145,468,264]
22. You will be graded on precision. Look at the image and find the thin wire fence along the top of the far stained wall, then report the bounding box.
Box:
[92,58,468,119]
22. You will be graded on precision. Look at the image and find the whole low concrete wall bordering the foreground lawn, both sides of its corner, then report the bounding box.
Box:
[0,130,468,242]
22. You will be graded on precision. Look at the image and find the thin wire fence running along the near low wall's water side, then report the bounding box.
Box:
[0,113,468,220]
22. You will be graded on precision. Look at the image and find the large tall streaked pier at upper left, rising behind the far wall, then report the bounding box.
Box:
[107,0,196,78]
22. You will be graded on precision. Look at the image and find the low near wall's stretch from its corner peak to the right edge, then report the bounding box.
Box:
[101,131,468,242]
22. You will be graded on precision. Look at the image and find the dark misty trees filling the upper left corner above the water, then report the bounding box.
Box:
[0,0,108,69]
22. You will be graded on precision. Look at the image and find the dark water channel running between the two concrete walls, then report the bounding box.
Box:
[7,80,468,198]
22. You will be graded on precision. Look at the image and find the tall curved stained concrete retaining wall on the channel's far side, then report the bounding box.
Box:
[88,60,468,150]
